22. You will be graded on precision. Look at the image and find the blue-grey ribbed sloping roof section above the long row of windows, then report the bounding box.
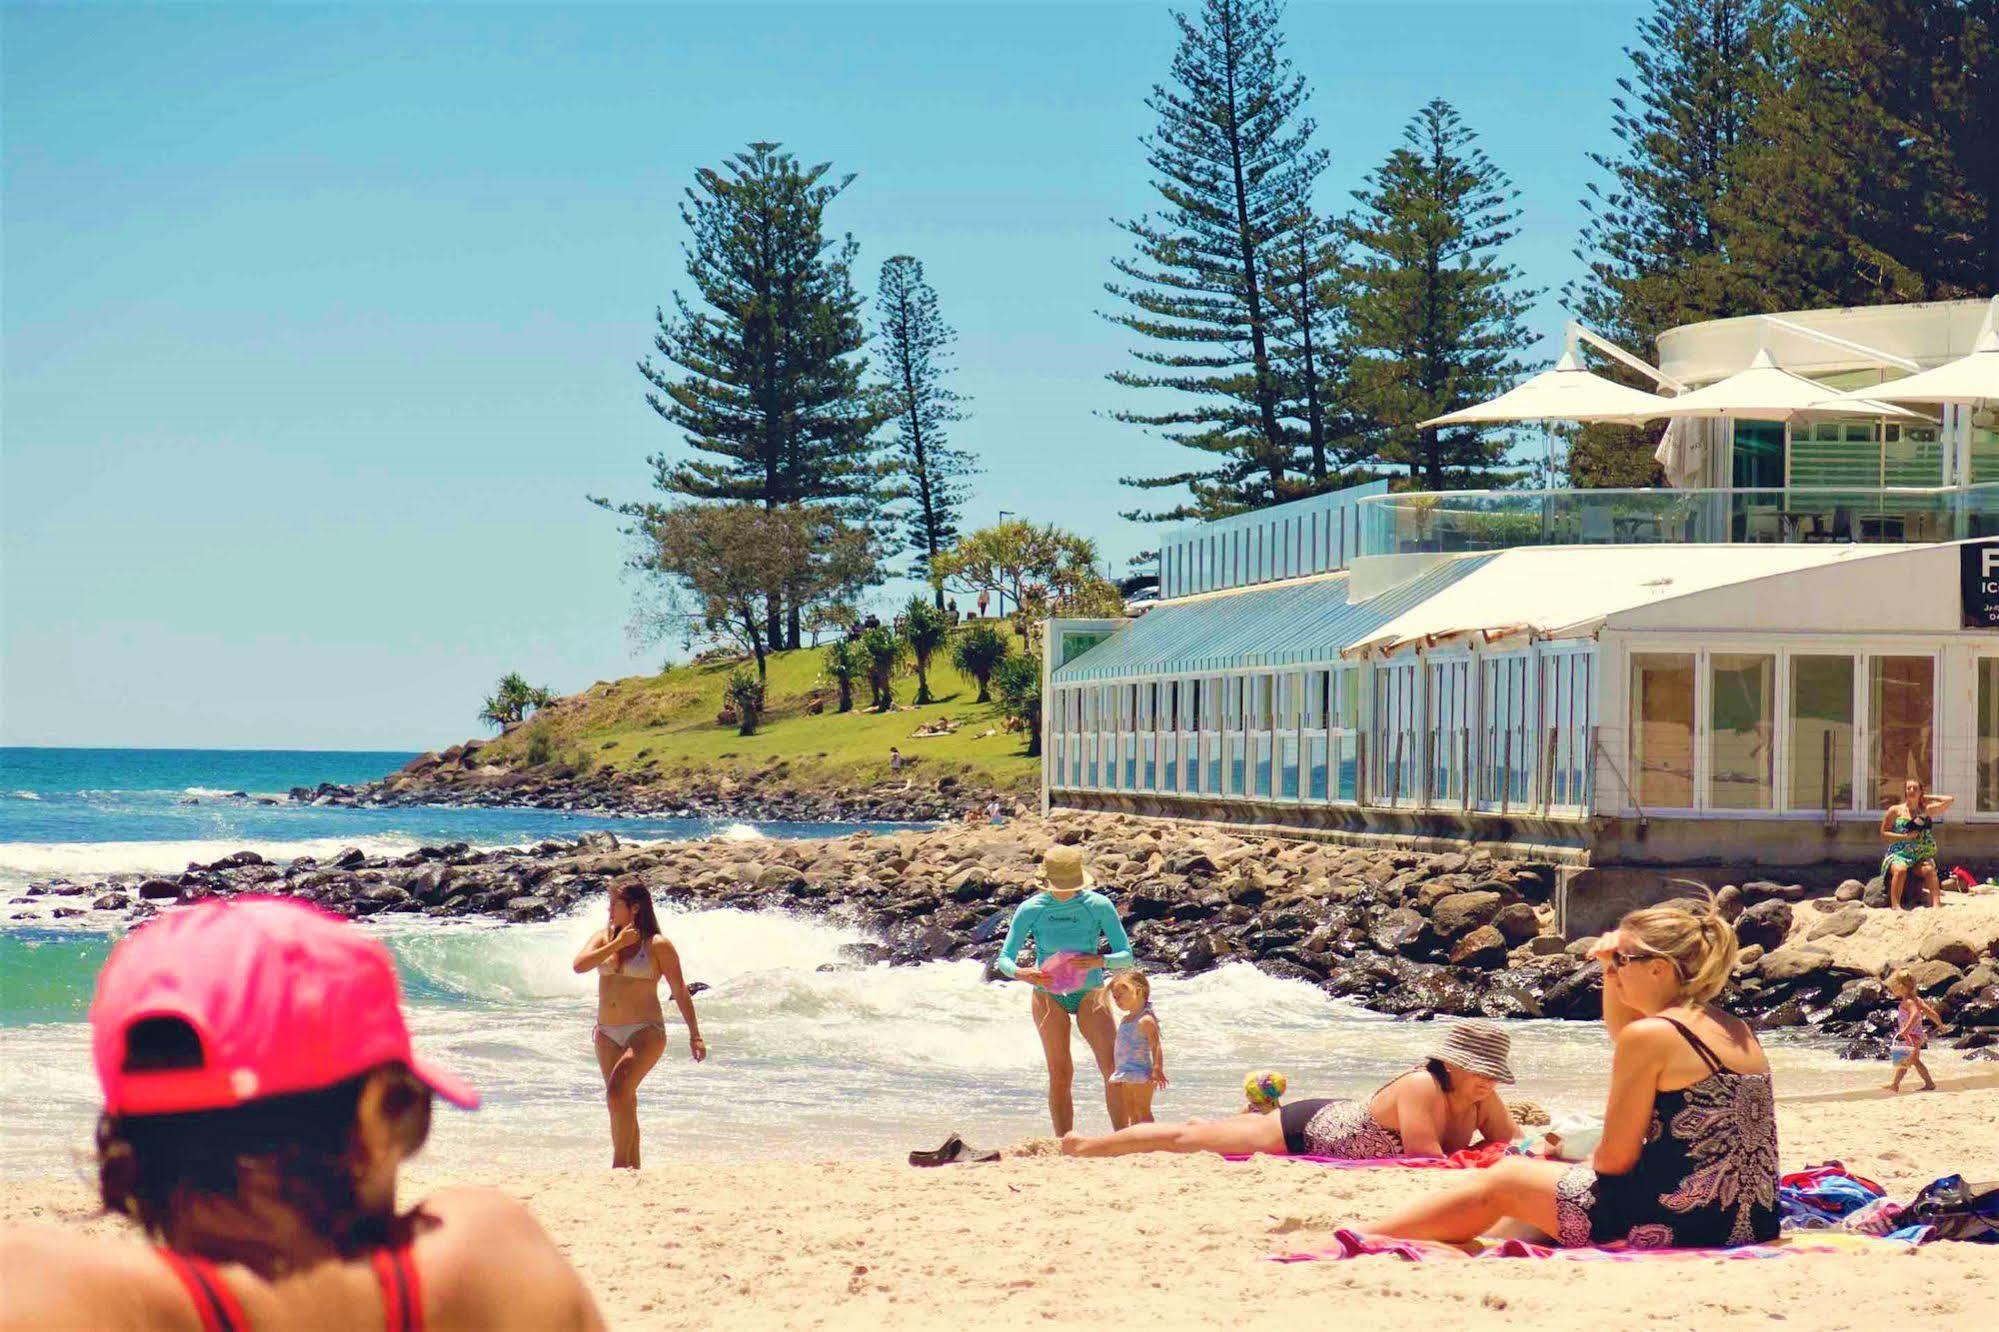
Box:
[1051,554,1501,684]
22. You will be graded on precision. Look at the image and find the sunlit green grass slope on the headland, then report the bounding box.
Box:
[480,624,1039,790]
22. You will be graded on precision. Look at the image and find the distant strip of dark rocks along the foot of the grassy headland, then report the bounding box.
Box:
[290,740,1017,824]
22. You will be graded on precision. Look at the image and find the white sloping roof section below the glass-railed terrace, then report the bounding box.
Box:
[1347,542,1905,654]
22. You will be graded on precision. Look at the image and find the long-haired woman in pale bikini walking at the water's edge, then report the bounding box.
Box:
[576,878,708,1170]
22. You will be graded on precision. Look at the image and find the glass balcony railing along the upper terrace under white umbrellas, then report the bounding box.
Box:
[1357,482,1999,556]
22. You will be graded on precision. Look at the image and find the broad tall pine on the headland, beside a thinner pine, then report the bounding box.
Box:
[594,142,882,648]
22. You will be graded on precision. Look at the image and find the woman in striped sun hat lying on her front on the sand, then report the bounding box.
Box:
[1061,1022,1519,1160]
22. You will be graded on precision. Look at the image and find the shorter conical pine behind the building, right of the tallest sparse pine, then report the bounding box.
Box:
[1347,98,1537,490]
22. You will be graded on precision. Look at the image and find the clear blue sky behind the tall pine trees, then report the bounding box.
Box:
[0,0,1641,748]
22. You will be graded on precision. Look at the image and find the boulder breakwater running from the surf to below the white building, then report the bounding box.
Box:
[12,814,1999,1058]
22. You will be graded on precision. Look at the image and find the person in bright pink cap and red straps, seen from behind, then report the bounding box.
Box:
[0,896,604,1332]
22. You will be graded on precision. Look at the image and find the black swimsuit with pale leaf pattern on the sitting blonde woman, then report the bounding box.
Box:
[1555,1018,1777,1248]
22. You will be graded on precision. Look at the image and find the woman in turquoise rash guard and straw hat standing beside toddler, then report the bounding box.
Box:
[998,846,1131,1138]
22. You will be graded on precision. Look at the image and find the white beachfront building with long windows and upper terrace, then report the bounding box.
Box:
[1043,302,1999,872]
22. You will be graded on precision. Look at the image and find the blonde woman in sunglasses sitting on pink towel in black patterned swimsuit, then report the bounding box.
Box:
[1367,902,1777,1248]
